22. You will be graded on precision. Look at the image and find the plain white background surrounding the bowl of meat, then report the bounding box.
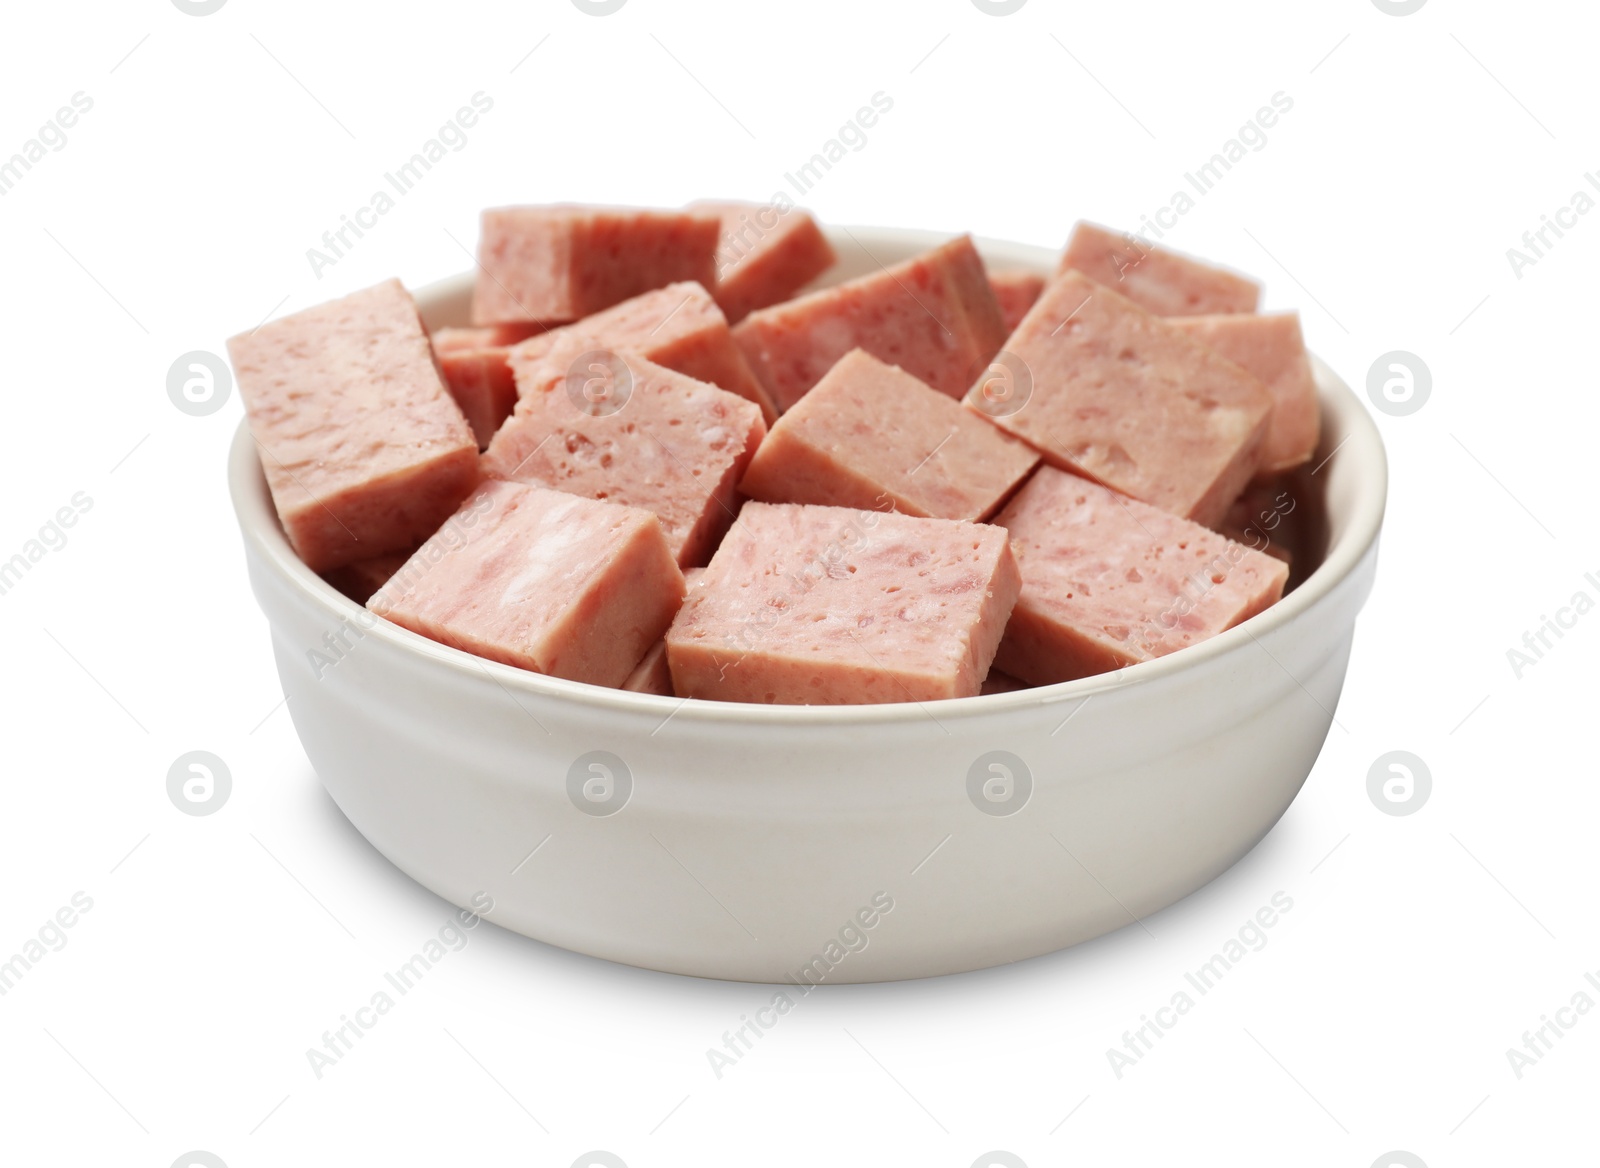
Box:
[0,0,1600,1168]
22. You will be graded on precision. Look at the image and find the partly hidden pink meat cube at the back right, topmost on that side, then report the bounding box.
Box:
[1056,222,1261,317]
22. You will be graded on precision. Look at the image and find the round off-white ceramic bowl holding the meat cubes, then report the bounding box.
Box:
[229,227,1386,982]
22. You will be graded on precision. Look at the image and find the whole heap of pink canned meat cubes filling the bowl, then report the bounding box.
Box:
[229,202,1320,704]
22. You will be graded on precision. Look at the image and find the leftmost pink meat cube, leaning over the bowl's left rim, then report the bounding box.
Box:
[227,280,478,571]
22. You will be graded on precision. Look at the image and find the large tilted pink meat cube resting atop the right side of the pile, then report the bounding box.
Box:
[966,272,1272,525]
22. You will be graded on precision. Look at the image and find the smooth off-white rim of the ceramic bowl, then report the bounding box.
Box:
[227,224,1389,730]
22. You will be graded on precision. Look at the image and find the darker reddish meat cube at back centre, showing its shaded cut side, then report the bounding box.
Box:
[733,235,1005,410]
